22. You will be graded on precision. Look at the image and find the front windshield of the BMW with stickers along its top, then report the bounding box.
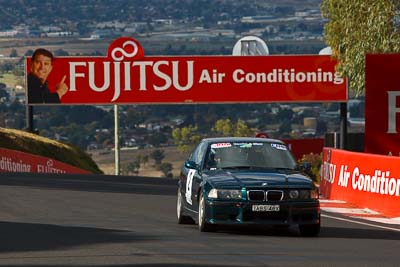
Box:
[204,142,296,170]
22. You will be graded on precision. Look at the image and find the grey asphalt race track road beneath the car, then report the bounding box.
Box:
[0,173,400,267]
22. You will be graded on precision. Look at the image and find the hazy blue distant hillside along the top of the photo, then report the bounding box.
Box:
[0,0,321,28]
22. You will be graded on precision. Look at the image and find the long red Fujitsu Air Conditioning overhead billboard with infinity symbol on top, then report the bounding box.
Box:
[26,37,347,105]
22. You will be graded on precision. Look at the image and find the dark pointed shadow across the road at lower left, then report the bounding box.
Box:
[0,222,157,253]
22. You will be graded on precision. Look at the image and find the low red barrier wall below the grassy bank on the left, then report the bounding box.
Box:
[0,148,90,174]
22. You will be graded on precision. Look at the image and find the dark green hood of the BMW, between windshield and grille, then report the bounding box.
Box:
[203,170,314,188]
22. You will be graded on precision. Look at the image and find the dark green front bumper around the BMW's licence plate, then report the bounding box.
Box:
[205,199,321,226]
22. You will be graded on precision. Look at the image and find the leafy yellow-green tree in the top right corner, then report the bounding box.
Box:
[321,0,400,95]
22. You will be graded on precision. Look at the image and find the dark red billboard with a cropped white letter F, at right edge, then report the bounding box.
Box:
[365,54,400,156]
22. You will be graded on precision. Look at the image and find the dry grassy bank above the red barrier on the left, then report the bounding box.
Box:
[0,128,102,174]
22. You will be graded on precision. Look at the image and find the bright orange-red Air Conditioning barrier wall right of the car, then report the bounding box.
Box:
[320,148,400,217]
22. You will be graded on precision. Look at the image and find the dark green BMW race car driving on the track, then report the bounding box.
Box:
[177,137,320,236]
